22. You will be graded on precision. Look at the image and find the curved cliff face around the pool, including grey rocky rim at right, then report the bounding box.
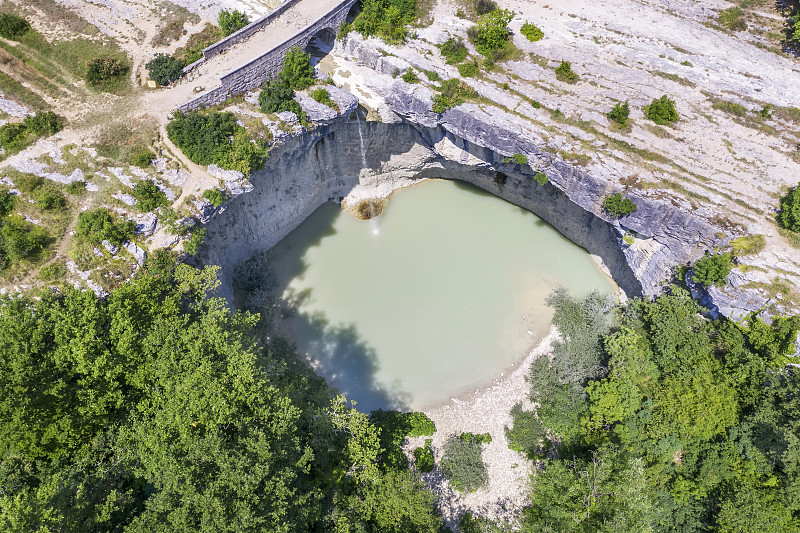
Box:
[195,117,715,306]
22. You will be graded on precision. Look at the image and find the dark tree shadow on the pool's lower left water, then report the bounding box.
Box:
[284,300,411,413]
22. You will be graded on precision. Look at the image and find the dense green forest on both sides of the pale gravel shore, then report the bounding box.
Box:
[0,253,800,533]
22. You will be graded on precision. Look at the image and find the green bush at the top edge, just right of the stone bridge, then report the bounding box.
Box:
[353,0,417,43]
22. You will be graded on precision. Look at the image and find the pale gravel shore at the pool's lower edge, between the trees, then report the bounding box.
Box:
[404,327,558,527]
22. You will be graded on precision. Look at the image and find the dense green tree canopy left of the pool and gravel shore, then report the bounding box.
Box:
[0,260,442,533]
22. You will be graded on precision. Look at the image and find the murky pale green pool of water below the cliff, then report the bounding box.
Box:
[272,180,615,411]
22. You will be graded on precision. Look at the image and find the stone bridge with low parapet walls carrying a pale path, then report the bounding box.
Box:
[180,0,358,111]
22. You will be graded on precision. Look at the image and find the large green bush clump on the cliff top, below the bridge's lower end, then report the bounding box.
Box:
[167,111,267,175]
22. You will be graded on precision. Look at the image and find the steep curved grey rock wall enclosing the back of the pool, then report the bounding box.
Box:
[194,121,650,298]
